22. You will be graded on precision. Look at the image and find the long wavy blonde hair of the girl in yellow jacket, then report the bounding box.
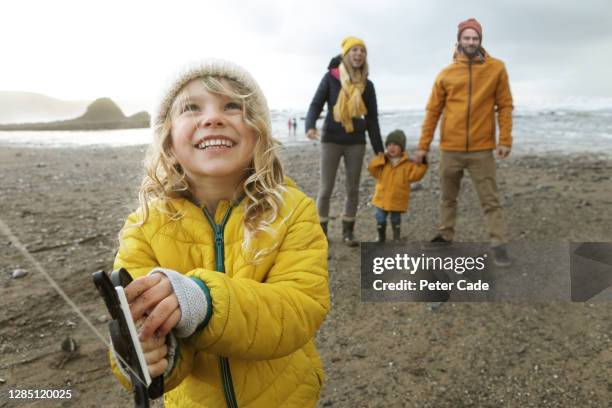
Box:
[139,75,285,262]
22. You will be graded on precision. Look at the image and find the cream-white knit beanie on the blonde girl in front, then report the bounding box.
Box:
[151,59,272,131]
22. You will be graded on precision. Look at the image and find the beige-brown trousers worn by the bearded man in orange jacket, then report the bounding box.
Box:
[439,150,507,246]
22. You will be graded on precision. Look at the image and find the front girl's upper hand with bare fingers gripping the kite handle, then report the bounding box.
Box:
[125,273,181,341]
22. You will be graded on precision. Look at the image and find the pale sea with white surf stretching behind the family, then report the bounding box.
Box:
[0,108,612,155]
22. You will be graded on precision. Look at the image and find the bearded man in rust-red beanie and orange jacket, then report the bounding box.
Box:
[414,18,512,266]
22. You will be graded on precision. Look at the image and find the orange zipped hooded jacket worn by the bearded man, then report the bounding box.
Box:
[419,52,512,152]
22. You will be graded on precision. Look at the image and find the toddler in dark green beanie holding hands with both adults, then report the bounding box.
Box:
[368,129,427,242]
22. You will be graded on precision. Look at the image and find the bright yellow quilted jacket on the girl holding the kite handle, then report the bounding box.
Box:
[111,185,330,408]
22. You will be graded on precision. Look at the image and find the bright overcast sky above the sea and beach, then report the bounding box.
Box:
[0,0,612,113]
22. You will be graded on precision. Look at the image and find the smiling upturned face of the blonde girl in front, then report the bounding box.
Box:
[170,79,257,182]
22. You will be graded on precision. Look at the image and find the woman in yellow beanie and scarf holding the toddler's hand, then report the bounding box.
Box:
[306,37,383,246]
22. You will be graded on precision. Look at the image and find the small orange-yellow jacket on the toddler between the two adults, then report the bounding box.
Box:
[368,152,427,212]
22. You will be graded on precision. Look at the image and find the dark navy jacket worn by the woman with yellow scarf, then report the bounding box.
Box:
[306,55,384,153]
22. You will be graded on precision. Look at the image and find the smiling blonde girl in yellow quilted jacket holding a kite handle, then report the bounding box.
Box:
[111,61,329,407]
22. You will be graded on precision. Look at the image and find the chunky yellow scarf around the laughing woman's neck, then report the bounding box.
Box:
[334,64,368,133]
